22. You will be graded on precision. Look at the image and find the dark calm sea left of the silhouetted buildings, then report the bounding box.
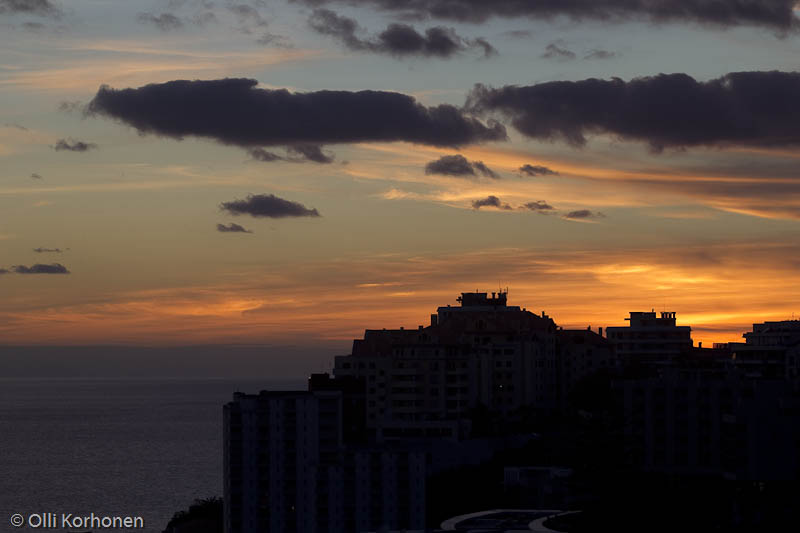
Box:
[0,379,304,532]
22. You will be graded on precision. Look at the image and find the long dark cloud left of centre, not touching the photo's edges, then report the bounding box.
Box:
[88,78,506,147]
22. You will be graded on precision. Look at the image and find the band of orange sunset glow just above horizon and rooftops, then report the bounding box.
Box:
[0,245,800,346]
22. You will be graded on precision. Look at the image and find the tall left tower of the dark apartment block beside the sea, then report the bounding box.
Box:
[224,391,343,533]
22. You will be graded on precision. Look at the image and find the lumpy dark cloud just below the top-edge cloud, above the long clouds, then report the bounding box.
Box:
[308,9,490,58]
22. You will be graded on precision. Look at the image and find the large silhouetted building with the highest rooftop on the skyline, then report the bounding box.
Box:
[334,292,559,440]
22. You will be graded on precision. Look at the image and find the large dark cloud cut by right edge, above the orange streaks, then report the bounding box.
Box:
[466,71,800,151]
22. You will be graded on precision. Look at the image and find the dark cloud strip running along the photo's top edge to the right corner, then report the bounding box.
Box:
[293,0,798,32]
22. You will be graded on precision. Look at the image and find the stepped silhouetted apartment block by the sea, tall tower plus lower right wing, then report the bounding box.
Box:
[224,386,430,533]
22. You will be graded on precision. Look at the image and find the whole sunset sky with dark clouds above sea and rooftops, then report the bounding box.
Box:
[0,0,800,362]
